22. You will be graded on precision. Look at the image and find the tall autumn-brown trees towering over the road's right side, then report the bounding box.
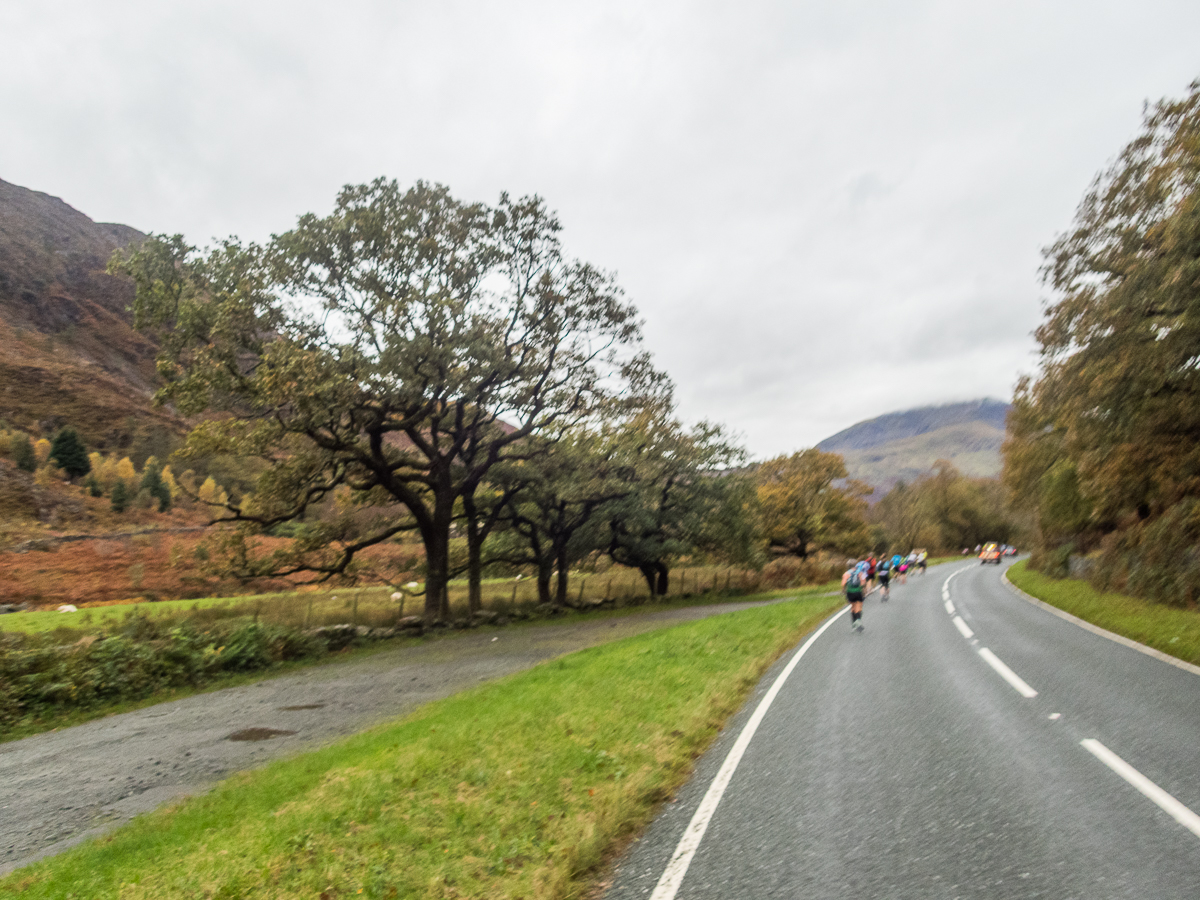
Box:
[1004,75,1200,601]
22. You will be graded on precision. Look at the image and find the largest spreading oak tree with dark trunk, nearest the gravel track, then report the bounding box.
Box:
[113,179,644,617]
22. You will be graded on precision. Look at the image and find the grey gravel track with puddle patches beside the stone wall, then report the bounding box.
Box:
[0,601,796,874]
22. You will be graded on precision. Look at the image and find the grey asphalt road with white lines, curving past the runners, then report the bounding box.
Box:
[605,560,1200,900]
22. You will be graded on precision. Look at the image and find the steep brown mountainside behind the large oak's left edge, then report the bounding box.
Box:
[0,180,178,446]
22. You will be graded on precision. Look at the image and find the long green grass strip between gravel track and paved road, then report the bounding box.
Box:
[0,595,840,900]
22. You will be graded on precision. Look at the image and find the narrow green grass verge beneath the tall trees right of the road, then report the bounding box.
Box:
[1008,560,1200,665]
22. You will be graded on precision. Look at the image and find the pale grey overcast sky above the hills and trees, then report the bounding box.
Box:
[0,0,1200,458]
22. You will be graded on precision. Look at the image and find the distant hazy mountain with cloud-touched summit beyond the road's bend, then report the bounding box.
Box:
[817,400,1009,497]
